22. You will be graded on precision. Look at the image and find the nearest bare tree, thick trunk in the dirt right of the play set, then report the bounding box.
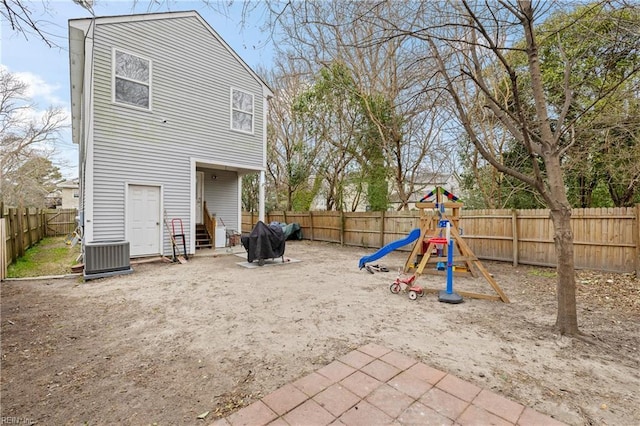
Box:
[424,1,578,335]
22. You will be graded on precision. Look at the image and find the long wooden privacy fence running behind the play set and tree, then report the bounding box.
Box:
[242,205,640,275]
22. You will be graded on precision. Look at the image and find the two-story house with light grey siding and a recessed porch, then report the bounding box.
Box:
[69,11,272,257]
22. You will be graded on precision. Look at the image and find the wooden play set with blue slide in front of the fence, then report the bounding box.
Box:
[358,187,509,303]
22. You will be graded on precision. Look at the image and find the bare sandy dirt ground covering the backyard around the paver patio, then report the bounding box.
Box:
[1,241,640,425]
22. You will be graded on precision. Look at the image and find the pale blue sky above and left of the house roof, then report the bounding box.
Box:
[0,0,273,179]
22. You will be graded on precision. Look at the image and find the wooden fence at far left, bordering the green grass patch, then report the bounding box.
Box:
[0,208,78,279]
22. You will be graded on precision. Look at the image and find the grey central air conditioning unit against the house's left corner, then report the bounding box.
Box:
[84,241,133,281]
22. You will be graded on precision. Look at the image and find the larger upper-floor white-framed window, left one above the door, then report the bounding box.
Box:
[113,49,151,109]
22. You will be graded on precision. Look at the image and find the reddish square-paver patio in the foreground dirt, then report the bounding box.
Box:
[213,344,563,426]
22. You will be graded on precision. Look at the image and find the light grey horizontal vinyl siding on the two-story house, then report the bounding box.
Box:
[86,17,266,253]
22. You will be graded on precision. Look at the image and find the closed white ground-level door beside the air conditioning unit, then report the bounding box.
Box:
[127,185,162,256]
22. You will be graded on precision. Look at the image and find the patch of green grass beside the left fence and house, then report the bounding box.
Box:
[7,237,80,278]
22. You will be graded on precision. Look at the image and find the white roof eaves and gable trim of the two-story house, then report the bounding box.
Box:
[69,10,273,143]
